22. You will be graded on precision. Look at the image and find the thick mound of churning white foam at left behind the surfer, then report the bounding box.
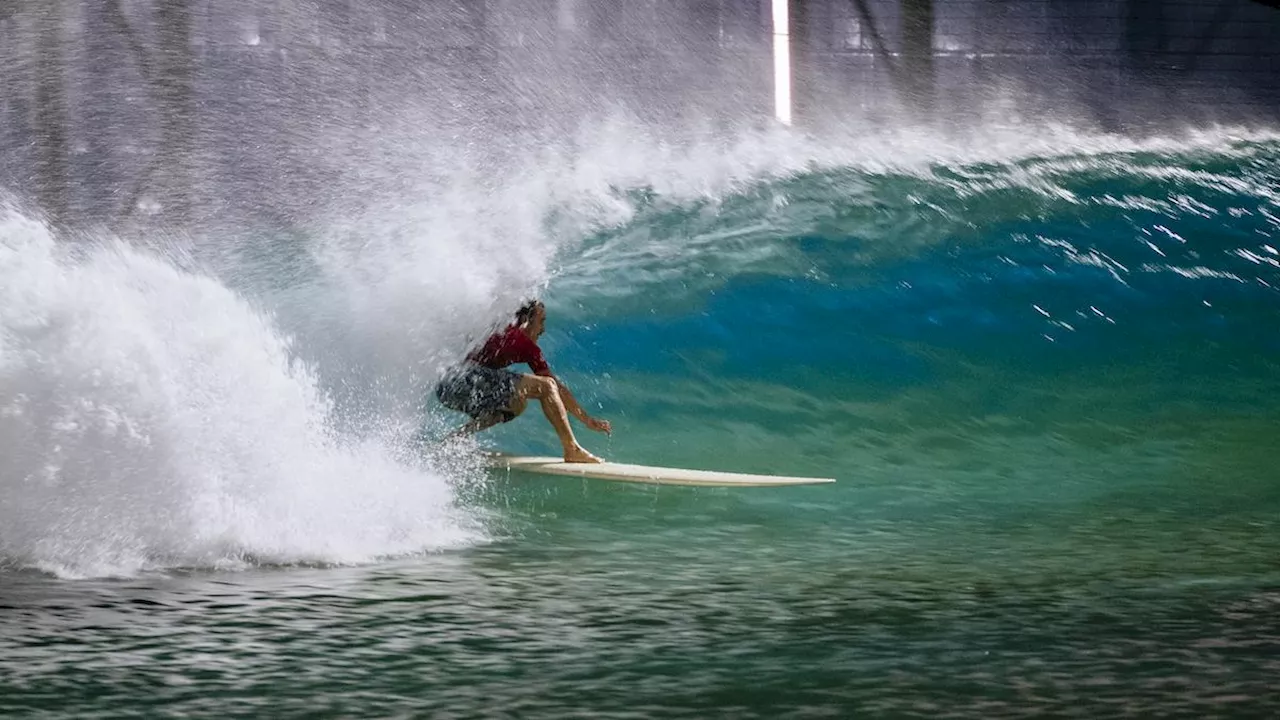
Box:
[0,206,479,575]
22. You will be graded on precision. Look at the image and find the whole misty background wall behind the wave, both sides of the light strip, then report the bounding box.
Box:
[0,0,1280,225]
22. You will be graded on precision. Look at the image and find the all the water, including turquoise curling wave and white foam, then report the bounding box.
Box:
[0,131,1280,717]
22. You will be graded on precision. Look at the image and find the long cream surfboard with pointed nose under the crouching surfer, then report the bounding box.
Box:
[489,452,836,488]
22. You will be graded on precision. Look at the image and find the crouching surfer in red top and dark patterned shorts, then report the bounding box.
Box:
[435,300,613,462]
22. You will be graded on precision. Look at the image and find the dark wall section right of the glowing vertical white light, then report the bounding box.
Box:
[795,0,1280,129]
